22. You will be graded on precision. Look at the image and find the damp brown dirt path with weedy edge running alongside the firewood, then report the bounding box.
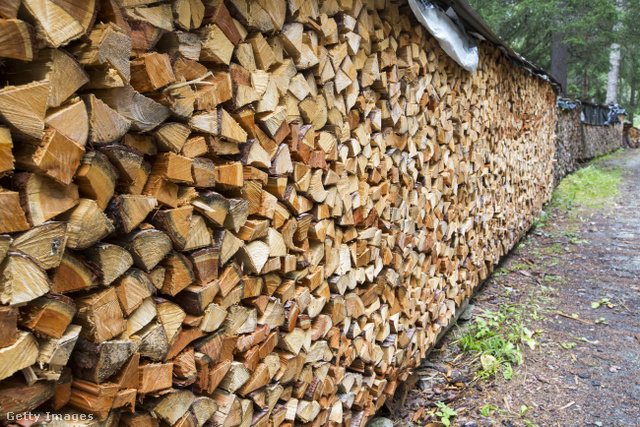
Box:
[384,150,640,427]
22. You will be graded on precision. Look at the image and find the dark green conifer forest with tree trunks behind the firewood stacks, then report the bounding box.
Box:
[470,0,640,125]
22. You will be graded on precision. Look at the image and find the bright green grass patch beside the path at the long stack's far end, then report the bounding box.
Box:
[552,159,622,210]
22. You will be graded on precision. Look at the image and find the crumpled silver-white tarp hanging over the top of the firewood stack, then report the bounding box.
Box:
[409,0,478,73]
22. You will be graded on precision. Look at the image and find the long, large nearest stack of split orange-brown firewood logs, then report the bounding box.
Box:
[0,0,555,427]
